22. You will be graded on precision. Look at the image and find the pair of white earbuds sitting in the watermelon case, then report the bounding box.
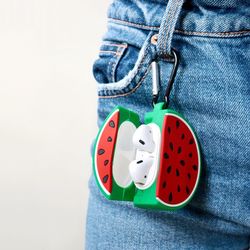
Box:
[129,124,155,185]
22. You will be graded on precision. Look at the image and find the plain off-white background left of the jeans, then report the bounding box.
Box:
[0,0,109,250]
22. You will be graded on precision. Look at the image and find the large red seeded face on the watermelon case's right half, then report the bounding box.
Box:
[156,114,200,207]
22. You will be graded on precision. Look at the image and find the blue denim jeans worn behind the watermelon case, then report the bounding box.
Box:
[86,0,250,250]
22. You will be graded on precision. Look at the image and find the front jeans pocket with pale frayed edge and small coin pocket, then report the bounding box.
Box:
[93,28,154,98]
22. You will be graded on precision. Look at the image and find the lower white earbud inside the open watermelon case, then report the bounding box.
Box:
[129,157,153,185]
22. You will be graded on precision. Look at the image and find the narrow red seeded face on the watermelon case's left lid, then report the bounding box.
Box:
[95,110,119,195]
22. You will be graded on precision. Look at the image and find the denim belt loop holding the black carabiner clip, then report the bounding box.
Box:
[156,0,184,57]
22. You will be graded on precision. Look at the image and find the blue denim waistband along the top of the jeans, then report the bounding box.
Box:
[108,0,250,36]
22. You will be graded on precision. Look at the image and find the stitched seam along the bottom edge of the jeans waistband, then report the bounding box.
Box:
[108,17,250,37]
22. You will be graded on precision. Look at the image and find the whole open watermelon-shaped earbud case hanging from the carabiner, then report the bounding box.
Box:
[93,103,201,210]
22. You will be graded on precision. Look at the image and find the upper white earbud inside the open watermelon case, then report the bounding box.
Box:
[133,124,155,153]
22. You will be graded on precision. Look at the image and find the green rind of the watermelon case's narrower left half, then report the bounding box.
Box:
[92,106,140,201]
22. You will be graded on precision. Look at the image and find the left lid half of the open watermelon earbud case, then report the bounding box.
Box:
[93,107,140,201]
